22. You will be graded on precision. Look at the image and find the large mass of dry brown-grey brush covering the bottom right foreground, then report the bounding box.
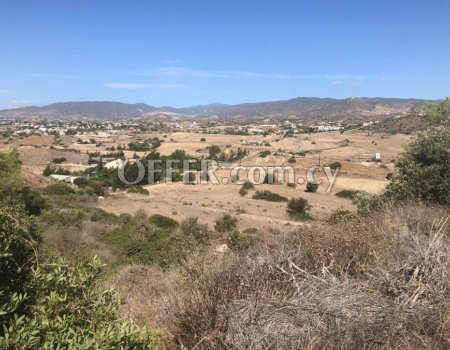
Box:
[159,205,450,349]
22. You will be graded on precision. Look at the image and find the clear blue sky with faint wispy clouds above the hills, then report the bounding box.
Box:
[0,0,450,108]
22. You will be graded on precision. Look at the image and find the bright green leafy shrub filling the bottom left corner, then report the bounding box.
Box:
[0,258,157,349]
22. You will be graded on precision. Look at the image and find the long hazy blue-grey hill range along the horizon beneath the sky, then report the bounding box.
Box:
[0,97,436,119]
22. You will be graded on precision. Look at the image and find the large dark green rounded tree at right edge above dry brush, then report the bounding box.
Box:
[385,126,450,205]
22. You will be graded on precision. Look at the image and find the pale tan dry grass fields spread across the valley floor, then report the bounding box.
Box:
[1,131,410,230]
